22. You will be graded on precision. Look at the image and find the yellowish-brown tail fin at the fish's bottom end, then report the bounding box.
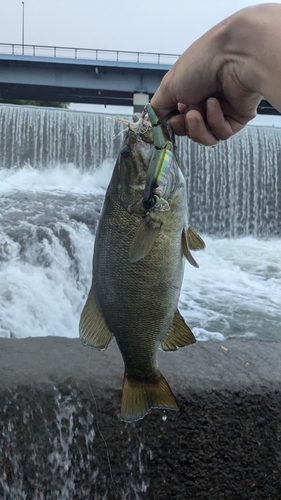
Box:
[121,373,179,422]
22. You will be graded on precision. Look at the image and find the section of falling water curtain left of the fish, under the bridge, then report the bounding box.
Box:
[0,105,123,171]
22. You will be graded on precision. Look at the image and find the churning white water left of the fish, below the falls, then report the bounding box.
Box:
[0,163,109,337]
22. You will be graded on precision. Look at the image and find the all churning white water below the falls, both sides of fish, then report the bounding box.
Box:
[0,163,281,340]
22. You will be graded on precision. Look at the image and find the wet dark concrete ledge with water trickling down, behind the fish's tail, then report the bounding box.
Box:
[0,337,281,500]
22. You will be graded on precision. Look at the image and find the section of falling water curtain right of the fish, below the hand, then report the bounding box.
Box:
[178,126,281,237]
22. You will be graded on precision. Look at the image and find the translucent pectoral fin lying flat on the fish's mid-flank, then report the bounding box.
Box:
[129,220,161,262]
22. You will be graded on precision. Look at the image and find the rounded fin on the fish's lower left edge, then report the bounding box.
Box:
[79,288,113,350]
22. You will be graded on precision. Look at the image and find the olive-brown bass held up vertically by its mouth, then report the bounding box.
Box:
[79,109,205,423]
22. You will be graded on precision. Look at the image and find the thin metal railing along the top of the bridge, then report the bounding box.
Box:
[0,43,179,65]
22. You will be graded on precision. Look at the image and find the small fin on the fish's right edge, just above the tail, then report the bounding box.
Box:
[161,309,196,351]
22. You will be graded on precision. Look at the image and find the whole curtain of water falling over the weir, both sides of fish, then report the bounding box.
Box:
[0,105,281,237]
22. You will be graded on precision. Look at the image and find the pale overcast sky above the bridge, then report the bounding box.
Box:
[0,0,281,125]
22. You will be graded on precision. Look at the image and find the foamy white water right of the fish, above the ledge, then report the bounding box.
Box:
[180,237,281,340]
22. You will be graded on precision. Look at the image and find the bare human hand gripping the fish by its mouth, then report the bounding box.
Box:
[151,9,272,146]
